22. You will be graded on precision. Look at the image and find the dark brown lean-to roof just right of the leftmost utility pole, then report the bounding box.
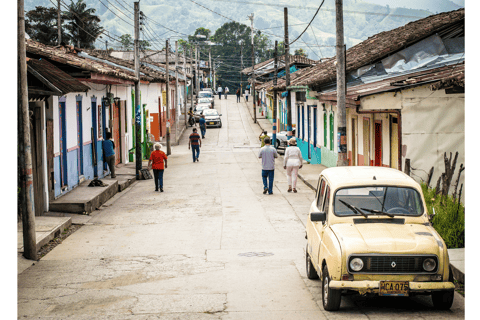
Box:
[27,59,90,94]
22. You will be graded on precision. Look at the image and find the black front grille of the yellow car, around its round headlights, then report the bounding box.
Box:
[348,255,438,274]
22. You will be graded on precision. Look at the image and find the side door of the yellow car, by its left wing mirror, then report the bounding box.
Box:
[307,178,327,271]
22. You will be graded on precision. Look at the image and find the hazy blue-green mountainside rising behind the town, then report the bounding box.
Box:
[25,0,461,59]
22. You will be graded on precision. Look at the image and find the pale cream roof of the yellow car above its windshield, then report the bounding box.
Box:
[320,166,419,189]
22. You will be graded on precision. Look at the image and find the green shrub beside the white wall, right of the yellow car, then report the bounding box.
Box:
[422,183,465,249]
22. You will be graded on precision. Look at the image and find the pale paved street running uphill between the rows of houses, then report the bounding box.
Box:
[18,95,465,320]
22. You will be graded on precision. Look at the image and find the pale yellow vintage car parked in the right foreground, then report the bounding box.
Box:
[305,167,455,311]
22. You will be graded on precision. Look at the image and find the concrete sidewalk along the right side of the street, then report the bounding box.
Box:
[243,99,465,284]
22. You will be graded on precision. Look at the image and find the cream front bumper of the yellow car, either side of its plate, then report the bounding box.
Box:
[330,280,455,294]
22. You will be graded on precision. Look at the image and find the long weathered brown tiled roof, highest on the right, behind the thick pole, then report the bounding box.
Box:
[277,9,465,90]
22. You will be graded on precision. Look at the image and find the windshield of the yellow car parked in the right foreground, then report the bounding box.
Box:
[334,186,423,216]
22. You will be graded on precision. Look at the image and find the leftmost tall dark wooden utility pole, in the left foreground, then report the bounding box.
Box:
[17,0,37,260]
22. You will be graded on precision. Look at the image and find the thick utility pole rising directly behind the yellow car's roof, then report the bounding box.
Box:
[335,0,348,167]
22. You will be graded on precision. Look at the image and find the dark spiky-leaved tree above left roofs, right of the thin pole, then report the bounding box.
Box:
[64,0,103,49]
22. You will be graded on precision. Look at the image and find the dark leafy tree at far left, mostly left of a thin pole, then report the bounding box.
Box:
[25,6,70,46]
